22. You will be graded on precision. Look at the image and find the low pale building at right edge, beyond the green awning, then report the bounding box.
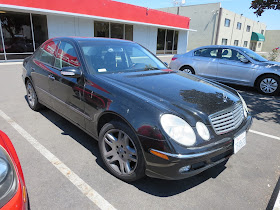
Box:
[263,30,280,52]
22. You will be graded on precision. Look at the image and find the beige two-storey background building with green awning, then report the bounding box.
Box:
[159,3,266,52]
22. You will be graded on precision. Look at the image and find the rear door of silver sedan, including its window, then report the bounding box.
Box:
[193,48,218,78]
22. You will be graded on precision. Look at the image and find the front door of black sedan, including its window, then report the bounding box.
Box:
[49,41,85,128]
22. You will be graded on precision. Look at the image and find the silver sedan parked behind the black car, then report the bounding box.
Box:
[169,45,280,95]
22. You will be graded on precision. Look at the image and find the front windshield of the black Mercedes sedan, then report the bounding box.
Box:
[80,40,166,74]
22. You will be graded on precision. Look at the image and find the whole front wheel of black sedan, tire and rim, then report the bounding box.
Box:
[98,121,145,182]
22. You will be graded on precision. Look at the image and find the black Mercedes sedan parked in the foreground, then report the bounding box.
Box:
[22,37,252,181]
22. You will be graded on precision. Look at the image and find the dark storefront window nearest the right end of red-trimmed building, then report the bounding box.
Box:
[157,29,179,54]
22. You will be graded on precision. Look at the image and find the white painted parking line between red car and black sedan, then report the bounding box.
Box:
[0,110,115,210]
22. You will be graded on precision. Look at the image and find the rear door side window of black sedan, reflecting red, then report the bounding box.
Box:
[34,41,58,65]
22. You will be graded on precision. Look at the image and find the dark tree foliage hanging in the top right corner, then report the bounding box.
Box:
[250,0,280,16]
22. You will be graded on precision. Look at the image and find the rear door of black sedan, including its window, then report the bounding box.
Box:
[29,40,58,106]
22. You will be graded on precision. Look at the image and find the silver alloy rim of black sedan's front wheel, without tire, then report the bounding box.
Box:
[102,129,137,175]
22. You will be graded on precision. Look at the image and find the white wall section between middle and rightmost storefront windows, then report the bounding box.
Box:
[133,25,157,54]
